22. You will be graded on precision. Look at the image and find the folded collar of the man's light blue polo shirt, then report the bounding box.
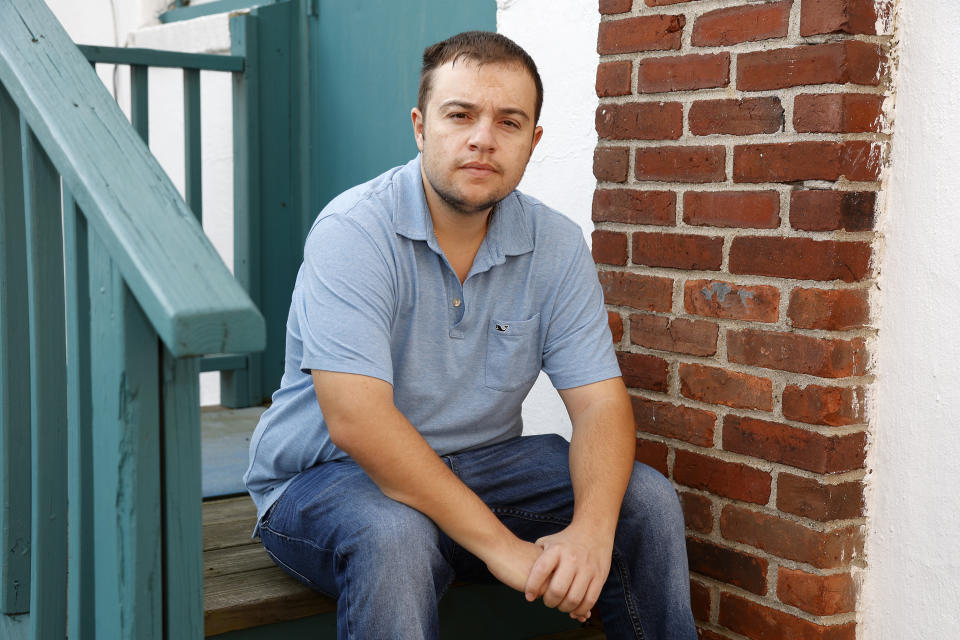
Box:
[393,154,533,266]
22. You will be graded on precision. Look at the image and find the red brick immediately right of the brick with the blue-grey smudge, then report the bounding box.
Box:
[787,287,870,331]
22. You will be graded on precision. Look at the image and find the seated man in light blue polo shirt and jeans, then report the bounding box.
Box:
[245,32,696,640]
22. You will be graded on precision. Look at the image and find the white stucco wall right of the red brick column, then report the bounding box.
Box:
[859,0,960,640]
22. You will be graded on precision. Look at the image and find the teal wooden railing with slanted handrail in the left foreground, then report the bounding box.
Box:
[0,0,265,640]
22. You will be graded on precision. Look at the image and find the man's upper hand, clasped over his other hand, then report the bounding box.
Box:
[524,526,613,622]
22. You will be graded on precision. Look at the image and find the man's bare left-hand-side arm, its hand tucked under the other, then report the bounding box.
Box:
[313,370,541,591]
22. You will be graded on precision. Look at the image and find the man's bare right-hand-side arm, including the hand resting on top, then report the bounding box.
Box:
[524,378,636,620]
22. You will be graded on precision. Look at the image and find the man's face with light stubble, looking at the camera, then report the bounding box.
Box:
[411,59,543,214]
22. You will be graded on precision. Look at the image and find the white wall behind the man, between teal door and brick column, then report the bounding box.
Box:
[497,0,600,438]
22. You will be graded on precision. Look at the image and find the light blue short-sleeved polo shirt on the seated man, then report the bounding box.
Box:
[244,156,620,519]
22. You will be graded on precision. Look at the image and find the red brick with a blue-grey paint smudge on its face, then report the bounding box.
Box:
[683,280,780,322]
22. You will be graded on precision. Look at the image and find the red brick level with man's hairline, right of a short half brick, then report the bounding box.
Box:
[637,53,730,93]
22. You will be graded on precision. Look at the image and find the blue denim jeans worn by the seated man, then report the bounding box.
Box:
[260,435,697,640]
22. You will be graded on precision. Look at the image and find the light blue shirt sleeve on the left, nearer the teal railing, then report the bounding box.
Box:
[294,216,396,384]
